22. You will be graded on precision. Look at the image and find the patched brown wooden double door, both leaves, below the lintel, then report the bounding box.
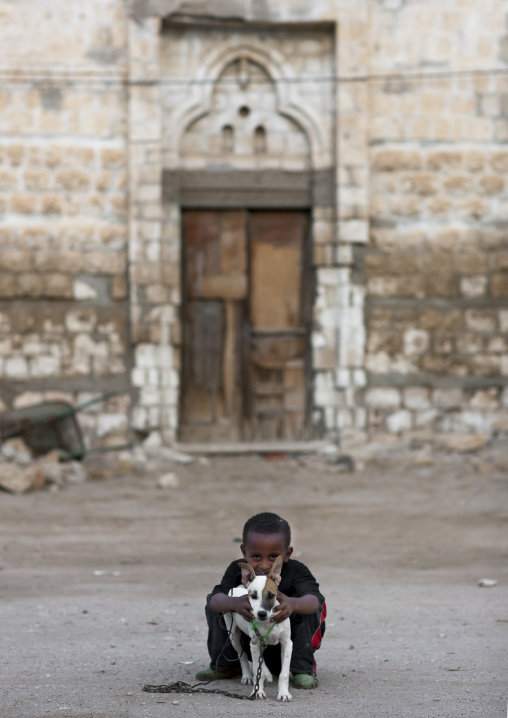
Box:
[180,210,312,442]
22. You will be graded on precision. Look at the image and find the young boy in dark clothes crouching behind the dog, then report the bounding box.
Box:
[196,513,326,688]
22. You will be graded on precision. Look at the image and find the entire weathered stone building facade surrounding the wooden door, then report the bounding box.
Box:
[0,0,508,448]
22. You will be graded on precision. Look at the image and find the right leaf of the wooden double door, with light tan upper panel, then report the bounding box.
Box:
[249,212,311,440]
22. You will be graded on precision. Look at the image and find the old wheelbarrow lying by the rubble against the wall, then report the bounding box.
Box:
[0,392,132,460]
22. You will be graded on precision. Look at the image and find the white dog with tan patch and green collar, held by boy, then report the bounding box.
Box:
[224,556,293,701]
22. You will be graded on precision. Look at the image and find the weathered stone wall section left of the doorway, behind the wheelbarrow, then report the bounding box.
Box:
[0,2,131,445]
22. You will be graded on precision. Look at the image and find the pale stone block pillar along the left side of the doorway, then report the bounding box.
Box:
[129,19,179,441]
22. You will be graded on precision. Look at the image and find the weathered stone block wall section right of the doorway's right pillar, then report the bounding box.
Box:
[364,2,508,438]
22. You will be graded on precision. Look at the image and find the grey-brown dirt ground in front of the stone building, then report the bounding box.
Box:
[0,444,508,718]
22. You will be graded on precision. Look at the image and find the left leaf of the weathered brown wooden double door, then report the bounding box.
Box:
[180,211,247,442]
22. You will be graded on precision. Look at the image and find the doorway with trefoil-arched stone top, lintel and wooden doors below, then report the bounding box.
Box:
[179,56,314,442]
